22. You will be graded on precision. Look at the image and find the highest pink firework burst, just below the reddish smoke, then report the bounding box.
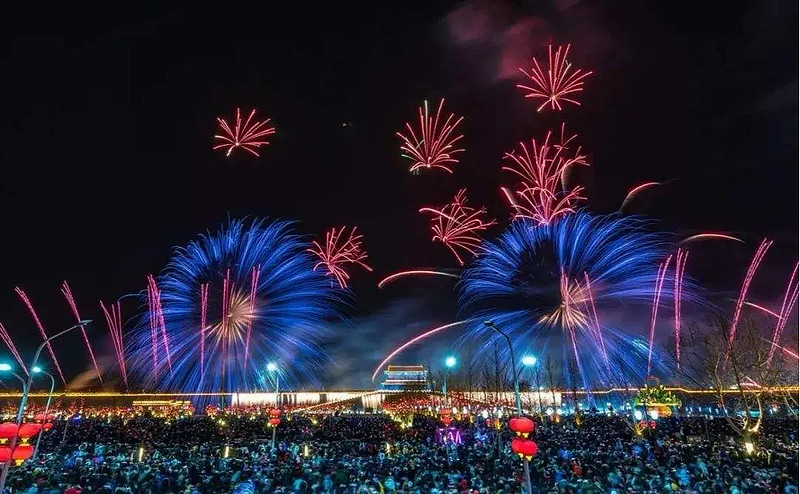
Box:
[517,45,592,112]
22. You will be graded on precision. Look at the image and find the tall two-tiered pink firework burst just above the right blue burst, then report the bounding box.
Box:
[501,123,589,225]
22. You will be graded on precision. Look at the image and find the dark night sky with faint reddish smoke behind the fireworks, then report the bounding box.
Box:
[0,0,798,386]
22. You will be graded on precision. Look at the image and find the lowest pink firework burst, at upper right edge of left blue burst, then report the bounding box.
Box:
[308,226,372,288]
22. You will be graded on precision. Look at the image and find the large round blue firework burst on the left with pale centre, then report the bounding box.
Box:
[130,220,341,392]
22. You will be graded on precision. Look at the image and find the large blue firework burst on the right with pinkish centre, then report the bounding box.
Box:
[459,213,693,386]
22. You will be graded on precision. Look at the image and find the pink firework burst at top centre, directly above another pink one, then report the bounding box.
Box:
[397,99,464,173]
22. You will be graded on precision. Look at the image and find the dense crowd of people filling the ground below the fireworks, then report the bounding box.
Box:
[0,412,798,494]
